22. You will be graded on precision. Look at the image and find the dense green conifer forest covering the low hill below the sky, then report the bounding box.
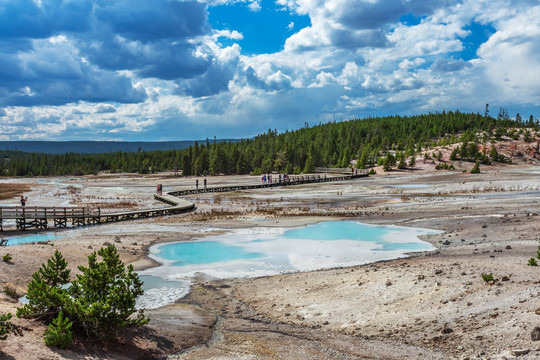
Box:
[0,109,539,176]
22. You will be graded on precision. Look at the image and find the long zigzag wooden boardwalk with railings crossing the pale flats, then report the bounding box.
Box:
[0,170,368,231]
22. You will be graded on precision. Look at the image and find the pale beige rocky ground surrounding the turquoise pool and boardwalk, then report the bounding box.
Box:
[0,139,540,359]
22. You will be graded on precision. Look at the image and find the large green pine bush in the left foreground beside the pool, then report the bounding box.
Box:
[17,245,149,339]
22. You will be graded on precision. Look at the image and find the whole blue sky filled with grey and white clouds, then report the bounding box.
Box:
[0,0,540,141]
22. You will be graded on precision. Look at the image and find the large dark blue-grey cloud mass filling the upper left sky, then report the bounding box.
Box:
[0,0,214,106]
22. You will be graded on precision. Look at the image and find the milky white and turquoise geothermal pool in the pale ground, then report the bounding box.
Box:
[138,221,440,308]
